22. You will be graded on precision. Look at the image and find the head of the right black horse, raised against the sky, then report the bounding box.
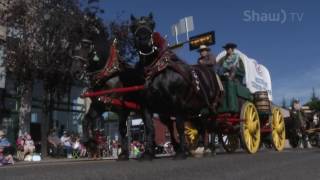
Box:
[130,13,156,55]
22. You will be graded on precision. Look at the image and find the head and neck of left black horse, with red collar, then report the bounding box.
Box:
[73,13,124,86]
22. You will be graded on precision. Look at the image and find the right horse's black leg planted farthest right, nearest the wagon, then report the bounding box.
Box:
[175,115,187,159]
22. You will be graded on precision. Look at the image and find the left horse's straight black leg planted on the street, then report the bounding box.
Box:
[118,110,129,161]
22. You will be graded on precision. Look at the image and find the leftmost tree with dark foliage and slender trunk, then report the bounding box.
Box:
[5,1,38,134]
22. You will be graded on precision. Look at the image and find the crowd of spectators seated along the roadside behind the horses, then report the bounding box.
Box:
[0,129,151,166]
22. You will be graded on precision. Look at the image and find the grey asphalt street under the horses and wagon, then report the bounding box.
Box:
[0,148,320,180]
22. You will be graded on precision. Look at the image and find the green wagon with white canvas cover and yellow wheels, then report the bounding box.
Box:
[186,49,286,154]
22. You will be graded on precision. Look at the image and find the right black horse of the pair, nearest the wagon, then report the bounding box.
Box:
[130,14,221,159]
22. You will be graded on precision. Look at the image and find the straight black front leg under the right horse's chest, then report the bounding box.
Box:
[140,109,155,160]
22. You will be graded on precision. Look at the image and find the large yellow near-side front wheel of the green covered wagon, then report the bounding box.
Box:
[240,102,260,154]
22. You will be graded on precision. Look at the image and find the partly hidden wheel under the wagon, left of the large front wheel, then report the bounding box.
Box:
[219,133,240,153]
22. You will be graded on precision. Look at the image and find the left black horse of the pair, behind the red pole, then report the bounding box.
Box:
[74,14,154,160]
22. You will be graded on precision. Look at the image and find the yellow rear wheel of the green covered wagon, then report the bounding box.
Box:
[271,108,286,151]
